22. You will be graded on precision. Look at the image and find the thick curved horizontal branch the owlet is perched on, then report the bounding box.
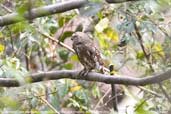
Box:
[0,70,171,87]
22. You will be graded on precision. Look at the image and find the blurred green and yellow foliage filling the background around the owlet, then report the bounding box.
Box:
[0,0,171,114]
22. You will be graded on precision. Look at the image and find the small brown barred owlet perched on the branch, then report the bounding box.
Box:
[71,32,103,76]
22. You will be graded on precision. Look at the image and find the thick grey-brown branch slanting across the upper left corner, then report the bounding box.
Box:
[0,0,88,26]
